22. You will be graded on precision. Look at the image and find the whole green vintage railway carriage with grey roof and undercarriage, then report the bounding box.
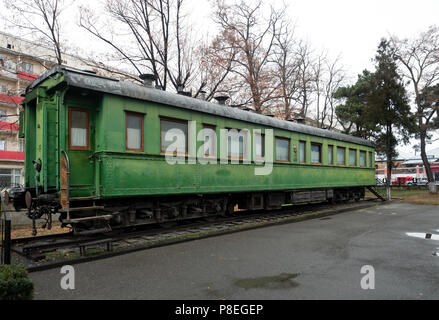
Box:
[10,66,375,235]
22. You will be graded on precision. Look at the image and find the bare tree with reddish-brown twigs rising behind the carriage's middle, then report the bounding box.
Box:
[215,0,283,113]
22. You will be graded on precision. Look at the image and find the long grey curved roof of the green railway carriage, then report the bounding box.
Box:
[26,65,374,147]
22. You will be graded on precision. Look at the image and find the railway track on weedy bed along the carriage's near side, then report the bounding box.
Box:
[12,200,381,272]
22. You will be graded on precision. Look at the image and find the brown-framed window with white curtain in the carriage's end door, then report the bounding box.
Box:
[69,108,90,150]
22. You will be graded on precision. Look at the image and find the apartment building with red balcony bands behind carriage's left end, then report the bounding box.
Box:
[0,32,133,190]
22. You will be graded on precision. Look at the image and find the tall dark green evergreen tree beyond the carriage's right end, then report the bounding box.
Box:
[335,39,414,198]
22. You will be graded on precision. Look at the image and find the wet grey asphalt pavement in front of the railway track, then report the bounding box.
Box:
[31,203,439,299]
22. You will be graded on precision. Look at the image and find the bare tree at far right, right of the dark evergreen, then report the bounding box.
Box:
[392,27,439,192]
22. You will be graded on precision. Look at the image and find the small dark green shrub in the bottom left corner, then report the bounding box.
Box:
[0,265,34,300]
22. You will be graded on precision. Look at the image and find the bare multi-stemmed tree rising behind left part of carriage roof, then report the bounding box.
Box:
[79,0,191,90]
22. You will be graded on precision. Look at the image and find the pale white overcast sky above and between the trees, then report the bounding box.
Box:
[3,0,439,158]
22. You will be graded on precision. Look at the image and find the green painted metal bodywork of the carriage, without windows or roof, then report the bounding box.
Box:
[25,81,375,197]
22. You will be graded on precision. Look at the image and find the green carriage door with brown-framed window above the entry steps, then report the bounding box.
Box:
[68,107,95,197]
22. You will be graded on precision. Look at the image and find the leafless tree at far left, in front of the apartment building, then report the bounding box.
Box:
[3,0,71,64]
